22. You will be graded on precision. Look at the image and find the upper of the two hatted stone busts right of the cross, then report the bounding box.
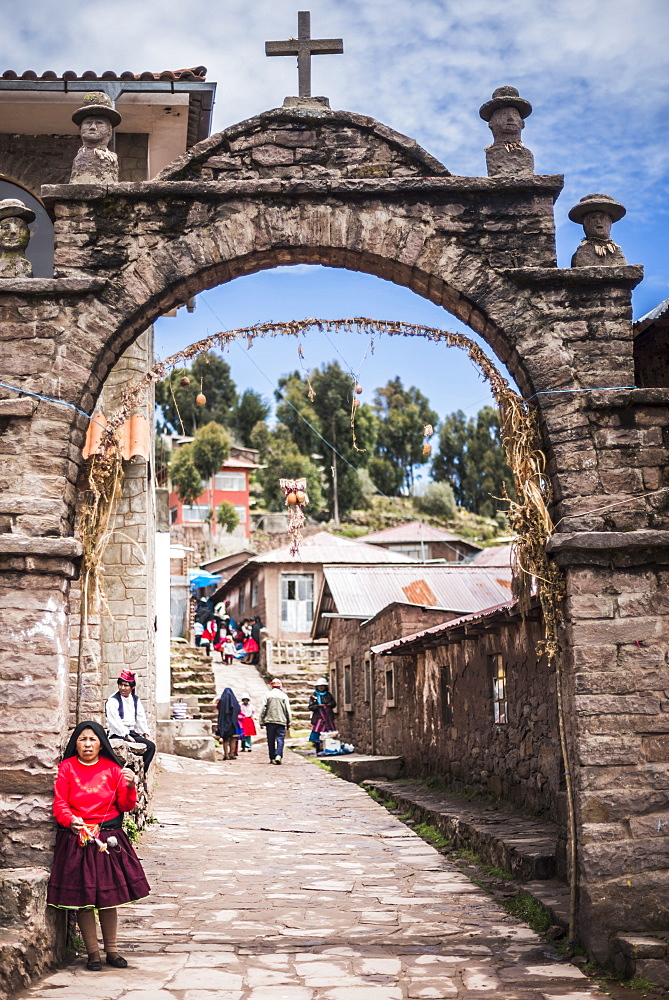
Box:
[479,87,534,177]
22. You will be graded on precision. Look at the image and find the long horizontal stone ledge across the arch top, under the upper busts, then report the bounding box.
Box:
[40,174,564,206]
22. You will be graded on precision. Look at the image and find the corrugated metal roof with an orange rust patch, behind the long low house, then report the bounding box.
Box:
[323,563,511,618]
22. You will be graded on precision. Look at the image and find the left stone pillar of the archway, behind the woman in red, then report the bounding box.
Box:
[0,534,81,868]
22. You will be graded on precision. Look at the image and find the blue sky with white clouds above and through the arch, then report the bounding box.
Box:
[6,0,669,422]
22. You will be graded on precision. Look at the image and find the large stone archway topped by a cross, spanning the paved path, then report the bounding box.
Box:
[0,108,669,957]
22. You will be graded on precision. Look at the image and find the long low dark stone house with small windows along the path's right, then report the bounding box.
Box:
[354,600,564,821]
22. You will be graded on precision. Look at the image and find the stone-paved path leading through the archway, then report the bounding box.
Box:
[23,745,603,1000]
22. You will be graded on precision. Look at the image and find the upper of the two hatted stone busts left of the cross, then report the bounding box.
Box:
[70,93,121,184]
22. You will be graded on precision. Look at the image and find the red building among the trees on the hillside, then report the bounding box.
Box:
[170,437,259,538]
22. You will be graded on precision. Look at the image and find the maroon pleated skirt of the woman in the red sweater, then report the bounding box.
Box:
[47,826,151,909]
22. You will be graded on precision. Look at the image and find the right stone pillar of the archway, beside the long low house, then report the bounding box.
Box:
[549,389,669,962]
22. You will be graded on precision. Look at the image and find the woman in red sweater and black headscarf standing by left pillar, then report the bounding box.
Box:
[47,722,150,972]
